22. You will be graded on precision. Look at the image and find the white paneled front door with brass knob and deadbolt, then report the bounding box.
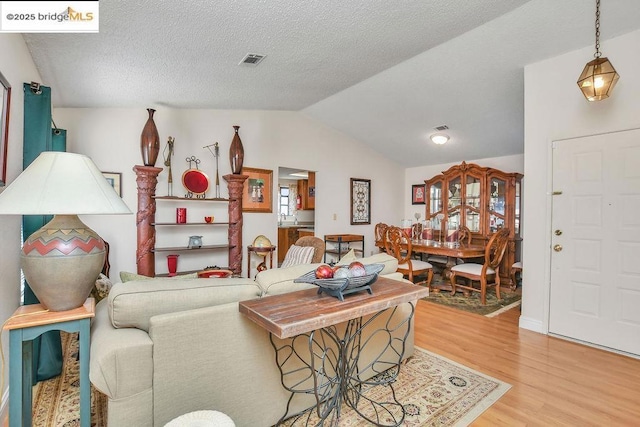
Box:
[549,130,640,355]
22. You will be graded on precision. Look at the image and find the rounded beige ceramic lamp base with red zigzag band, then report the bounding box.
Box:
[21,215,106,311]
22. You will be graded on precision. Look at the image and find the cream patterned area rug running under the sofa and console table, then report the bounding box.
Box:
[33,332,511,427]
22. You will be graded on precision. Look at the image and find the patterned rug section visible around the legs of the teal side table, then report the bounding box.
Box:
[32,332,107,427]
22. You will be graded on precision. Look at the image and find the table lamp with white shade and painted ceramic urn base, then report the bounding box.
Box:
[0,151,131,311]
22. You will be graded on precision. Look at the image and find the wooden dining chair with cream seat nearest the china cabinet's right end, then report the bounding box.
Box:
[449,228,509,305]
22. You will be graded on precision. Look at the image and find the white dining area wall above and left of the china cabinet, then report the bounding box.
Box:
[404,154,524,221]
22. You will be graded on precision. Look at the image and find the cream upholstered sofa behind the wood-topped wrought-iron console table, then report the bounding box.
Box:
[90,254,413,427]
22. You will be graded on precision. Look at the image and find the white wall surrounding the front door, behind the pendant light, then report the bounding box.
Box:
[520,31,640,333]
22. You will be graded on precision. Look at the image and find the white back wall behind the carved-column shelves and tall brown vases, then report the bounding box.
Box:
[54,106,404,279]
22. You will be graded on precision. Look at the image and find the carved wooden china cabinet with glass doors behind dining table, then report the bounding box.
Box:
[425,162,523,286]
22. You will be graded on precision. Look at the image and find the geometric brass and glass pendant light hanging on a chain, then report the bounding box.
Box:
[578,0,620,101]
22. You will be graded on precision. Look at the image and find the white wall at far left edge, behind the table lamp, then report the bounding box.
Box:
[0,34,41,420]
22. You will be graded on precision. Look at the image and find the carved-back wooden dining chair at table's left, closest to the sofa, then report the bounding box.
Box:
[385,226,433,288]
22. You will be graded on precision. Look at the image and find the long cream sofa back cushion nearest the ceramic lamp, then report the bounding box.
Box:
[109,278,263,332]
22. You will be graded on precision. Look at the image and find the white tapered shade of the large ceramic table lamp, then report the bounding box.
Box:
[0,151,131,215]
